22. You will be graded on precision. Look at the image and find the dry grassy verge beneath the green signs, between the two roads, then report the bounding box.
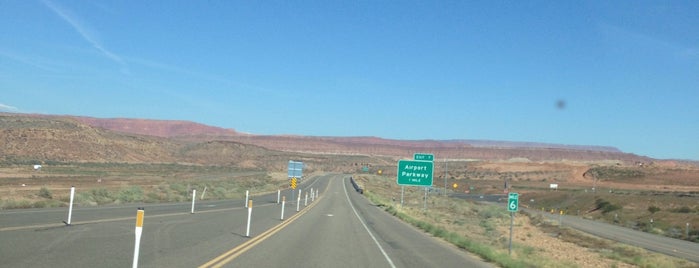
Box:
[354,175,696,267]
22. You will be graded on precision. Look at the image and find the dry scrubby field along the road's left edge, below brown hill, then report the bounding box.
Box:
[0,163,286,209]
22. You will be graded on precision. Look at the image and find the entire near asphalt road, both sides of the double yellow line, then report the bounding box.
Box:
[0,175,491,267]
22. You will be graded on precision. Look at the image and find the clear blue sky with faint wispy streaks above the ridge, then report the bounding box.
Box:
[0,0,699,160]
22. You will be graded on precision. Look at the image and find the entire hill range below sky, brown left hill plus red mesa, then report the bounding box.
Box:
[0,113,653,163]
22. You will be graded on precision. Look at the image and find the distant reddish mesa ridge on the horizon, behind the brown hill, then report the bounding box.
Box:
[68,113,649,162]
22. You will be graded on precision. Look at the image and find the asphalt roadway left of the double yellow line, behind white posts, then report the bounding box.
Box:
[0,175,325,267]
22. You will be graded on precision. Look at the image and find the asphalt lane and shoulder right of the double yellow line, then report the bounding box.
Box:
[230,175,493,267]
